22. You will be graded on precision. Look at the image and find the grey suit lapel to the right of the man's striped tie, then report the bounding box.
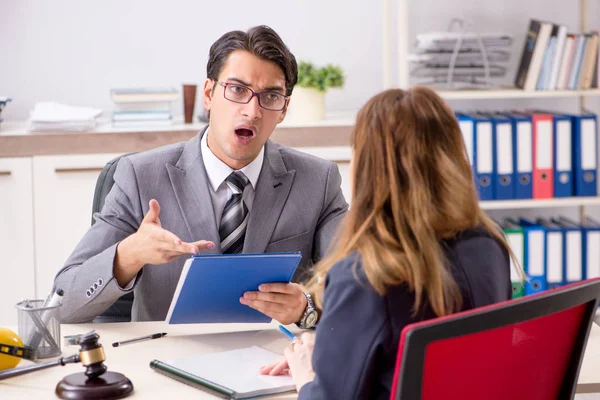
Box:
[243,140,296,253]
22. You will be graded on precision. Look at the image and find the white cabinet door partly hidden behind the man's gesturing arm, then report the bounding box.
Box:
[33,154,117,298]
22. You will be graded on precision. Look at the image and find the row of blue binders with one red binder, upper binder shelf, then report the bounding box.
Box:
[456,111,598,200]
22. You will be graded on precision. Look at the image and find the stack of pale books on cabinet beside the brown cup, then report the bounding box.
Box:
[111,87,178,127]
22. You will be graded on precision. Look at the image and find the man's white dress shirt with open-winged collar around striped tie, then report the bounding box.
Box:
[200,127,265,230]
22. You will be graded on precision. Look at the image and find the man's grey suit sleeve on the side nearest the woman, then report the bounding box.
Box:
[312,162,348,263]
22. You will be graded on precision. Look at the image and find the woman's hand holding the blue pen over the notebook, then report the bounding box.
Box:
[284,332,315,391]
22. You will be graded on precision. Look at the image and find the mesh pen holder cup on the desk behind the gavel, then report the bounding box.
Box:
[15,300,61,358]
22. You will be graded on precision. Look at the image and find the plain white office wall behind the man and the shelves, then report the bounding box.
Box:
[0,0,600,120]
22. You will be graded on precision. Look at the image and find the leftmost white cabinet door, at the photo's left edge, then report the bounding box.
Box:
[0,157,35,326]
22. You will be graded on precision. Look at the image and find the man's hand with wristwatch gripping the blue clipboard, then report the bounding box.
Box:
[240,283,308,325]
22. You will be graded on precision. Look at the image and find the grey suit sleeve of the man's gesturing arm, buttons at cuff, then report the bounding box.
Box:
[54,157,143,323]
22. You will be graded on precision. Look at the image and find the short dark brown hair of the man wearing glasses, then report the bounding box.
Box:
[206,25,298,96]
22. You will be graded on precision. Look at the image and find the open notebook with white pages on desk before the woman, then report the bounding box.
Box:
[150,346,296,399]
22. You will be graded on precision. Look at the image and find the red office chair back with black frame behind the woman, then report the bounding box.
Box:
[390,278,600,400]
